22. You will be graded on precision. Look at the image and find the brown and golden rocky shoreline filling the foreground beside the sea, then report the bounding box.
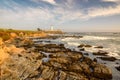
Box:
[0,34,112,80]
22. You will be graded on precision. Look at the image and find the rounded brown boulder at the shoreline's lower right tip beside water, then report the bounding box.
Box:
[92,64,112,80]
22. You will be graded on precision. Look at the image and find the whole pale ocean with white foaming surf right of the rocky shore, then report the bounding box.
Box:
[33,32,120,80]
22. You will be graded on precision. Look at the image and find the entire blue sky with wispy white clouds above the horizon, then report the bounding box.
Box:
[0,0,120,32]
